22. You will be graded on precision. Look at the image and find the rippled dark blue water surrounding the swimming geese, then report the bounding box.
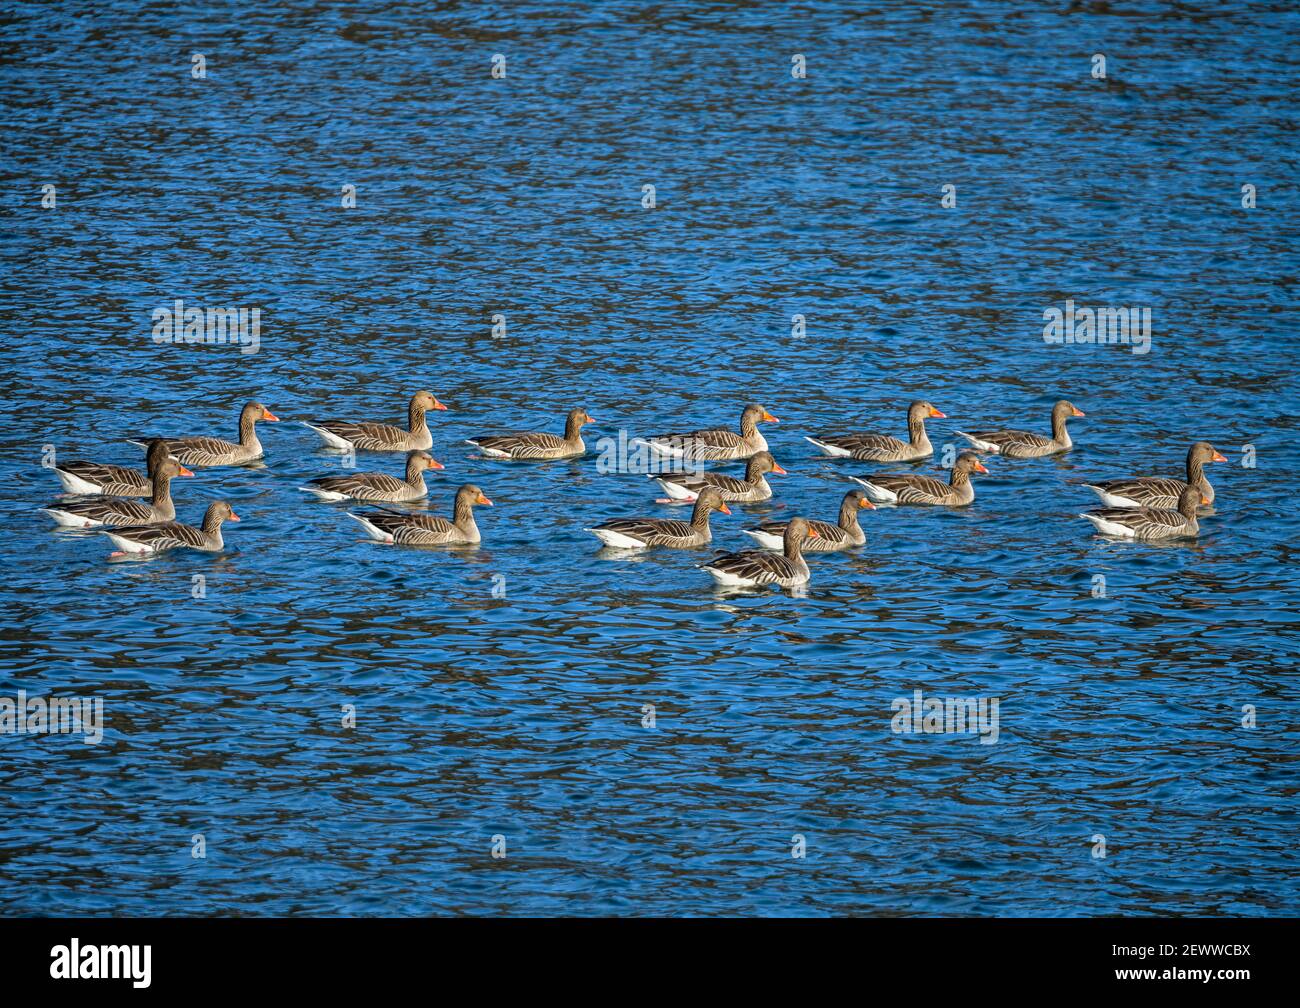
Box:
[0,0,1300,916]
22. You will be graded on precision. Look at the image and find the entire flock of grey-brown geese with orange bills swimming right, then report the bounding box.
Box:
[42,391,1226,588]
